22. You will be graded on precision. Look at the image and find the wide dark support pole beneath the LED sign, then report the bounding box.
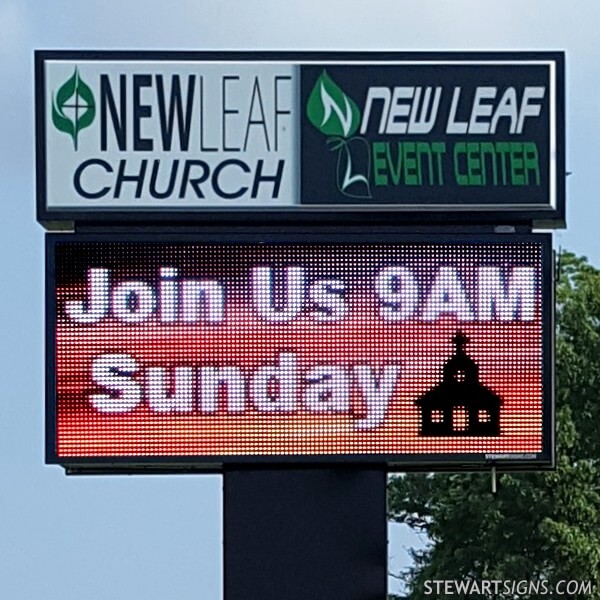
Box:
[223,468,387,600]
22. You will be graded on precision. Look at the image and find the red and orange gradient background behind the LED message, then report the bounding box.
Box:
[49,237,548,464]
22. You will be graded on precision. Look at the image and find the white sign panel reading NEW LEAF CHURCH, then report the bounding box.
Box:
[45,60,299,209]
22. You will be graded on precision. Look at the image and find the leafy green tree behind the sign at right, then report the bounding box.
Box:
[389,253,600,600]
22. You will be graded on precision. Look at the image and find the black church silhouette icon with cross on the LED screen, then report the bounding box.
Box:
[416,331,502,436]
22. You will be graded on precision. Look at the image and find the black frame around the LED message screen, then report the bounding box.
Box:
[45,229,555,474]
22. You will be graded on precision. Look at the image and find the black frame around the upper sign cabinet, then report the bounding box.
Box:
[35,50,566,229]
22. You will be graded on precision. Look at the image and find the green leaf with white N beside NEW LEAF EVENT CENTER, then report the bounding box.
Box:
[306,71,360,139]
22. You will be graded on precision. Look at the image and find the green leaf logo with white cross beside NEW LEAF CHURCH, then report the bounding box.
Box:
[52,67,96,150]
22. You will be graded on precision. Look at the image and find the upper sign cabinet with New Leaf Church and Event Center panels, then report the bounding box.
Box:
[36,51,565,227]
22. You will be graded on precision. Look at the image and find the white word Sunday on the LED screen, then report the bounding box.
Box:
[89,352,400,430]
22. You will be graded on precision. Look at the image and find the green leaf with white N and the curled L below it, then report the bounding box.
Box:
[306,70,372,198]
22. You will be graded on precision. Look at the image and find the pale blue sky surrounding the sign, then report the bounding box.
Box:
[0,0,600,600]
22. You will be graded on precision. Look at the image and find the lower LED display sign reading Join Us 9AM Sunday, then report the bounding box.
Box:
[47,233,553,472]
